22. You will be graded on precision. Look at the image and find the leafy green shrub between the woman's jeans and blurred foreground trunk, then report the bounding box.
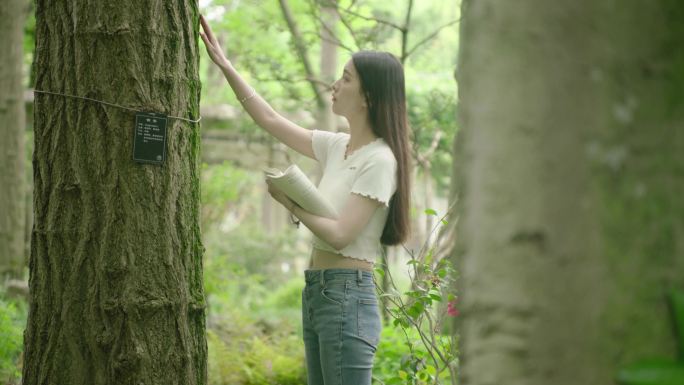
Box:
[376,206,458,385]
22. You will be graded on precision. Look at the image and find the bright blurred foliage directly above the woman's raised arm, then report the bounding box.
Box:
[200,0,315,110]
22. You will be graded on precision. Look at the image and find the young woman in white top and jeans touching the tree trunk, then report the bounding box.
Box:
[200,17,410,385]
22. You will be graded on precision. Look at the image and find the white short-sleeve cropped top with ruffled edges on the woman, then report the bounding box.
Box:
[312,130,397,263]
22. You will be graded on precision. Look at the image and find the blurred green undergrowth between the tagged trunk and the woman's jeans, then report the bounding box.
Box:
[204,190,306,385]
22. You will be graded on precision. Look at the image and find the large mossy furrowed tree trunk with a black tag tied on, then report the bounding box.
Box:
[23,0,207,385]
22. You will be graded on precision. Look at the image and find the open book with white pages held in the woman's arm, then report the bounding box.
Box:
[263,164,338,219]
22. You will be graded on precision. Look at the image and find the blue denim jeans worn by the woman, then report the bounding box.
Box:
[302,269,382,385]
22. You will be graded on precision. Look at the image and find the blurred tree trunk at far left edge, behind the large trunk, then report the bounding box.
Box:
[0,0,28,283]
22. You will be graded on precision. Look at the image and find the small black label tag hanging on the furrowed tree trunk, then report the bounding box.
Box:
[133,112,167,164]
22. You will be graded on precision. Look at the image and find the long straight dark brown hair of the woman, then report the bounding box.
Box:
[352,51,411,246]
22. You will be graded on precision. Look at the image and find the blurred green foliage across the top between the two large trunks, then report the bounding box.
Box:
[200,0,459,123]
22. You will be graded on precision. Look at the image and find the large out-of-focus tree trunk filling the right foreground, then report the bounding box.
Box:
[450,0,684,385]
